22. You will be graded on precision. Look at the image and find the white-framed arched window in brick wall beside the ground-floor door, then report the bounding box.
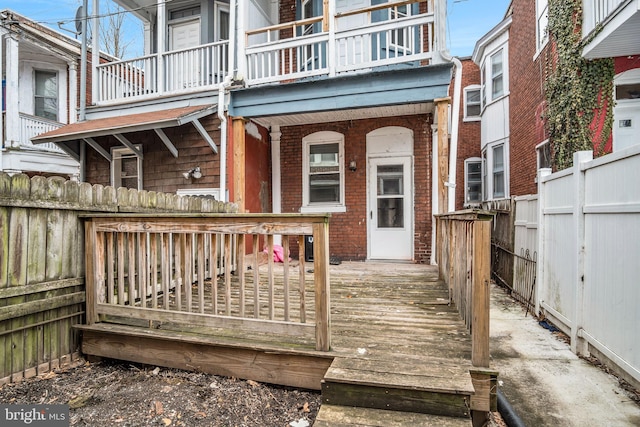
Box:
[301,132,346,212]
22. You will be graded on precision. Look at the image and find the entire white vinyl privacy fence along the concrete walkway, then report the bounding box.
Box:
[536,150,640,381]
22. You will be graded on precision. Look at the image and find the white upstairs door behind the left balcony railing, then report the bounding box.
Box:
[167,18,201,90]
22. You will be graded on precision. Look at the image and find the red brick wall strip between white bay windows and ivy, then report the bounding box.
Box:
[509,0,549,196]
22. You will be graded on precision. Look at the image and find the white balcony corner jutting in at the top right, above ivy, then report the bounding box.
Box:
[582,0,640,59]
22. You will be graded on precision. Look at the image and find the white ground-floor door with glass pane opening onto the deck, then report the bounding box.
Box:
[368,156,413,260]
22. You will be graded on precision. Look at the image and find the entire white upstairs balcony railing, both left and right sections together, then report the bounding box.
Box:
[94,0,446,106]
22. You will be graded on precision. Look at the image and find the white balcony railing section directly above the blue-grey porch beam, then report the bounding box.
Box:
[245,1,435,85]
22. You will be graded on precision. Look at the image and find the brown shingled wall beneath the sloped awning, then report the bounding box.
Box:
[86,115,220,193]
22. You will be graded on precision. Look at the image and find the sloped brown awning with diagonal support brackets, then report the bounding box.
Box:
[31,105,218,160]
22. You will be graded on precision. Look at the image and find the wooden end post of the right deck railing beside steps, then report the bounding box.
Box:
[471,220,491,368]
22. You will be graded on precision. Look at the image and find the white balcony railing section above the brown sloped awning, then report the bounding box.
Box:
[96,41,229,104]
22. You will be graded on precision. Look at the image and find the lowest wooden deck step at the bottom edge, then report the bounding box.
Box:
[313,405,471,427]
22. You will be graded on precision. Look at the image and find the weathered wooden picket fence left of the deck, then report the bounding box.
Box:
[0,173,234,384]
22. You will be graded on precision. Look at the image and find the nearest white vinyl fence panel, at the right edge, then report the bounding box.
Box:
[583,149,640,378]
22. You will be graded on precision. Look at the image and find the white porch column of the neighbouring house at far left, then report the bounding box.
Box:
[5,36,20,147]
